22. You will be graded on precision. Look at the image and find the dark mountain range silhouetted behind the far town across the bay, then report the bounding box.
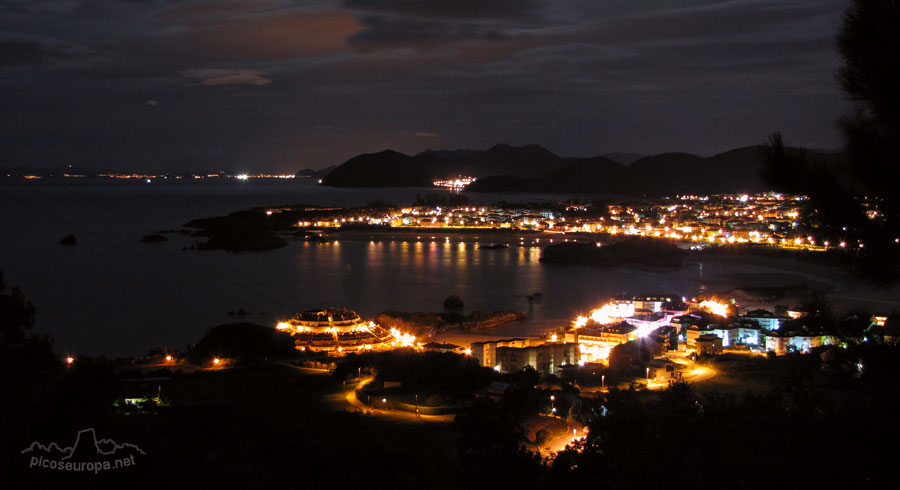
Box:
[322,144,842,196]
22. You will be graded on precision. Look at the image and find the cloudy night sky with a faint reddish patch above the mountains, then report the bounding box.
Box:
[0,0,849,172]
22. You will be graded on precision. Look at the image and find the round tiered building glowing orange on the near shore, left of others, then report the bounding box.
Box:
[275,308,415,355]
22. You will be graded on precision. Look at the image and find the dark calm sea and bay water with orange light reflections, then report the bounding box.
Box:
[0,183,844,356]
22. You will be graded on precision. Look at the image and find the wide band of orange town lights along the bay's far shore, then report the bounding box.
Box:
[284,192,888,252]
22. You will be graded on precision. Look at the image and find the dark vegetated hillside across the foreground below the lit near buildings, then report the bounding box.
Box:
[0,266,900,489]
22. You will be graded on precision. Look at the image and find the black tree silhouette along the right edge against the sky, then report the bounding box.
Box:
[761,0,900,282]
